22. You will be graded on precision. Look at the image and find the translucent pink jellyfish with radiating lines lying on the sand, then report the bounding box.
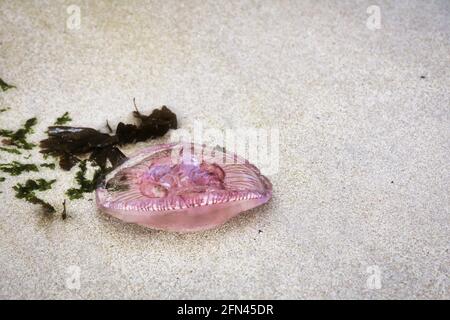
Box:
[96,142,272,232]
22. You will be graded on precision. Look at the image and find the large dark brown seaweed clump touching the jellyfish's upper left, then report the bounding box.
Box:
[40,99,177,171]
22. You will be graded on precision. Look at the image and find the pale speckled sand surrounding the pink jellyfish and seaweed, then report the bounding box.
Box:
[0,0,450,299]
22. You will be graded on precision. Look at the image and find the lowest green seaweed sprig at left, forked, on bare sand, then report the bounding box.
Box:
[13,179,56,214]
